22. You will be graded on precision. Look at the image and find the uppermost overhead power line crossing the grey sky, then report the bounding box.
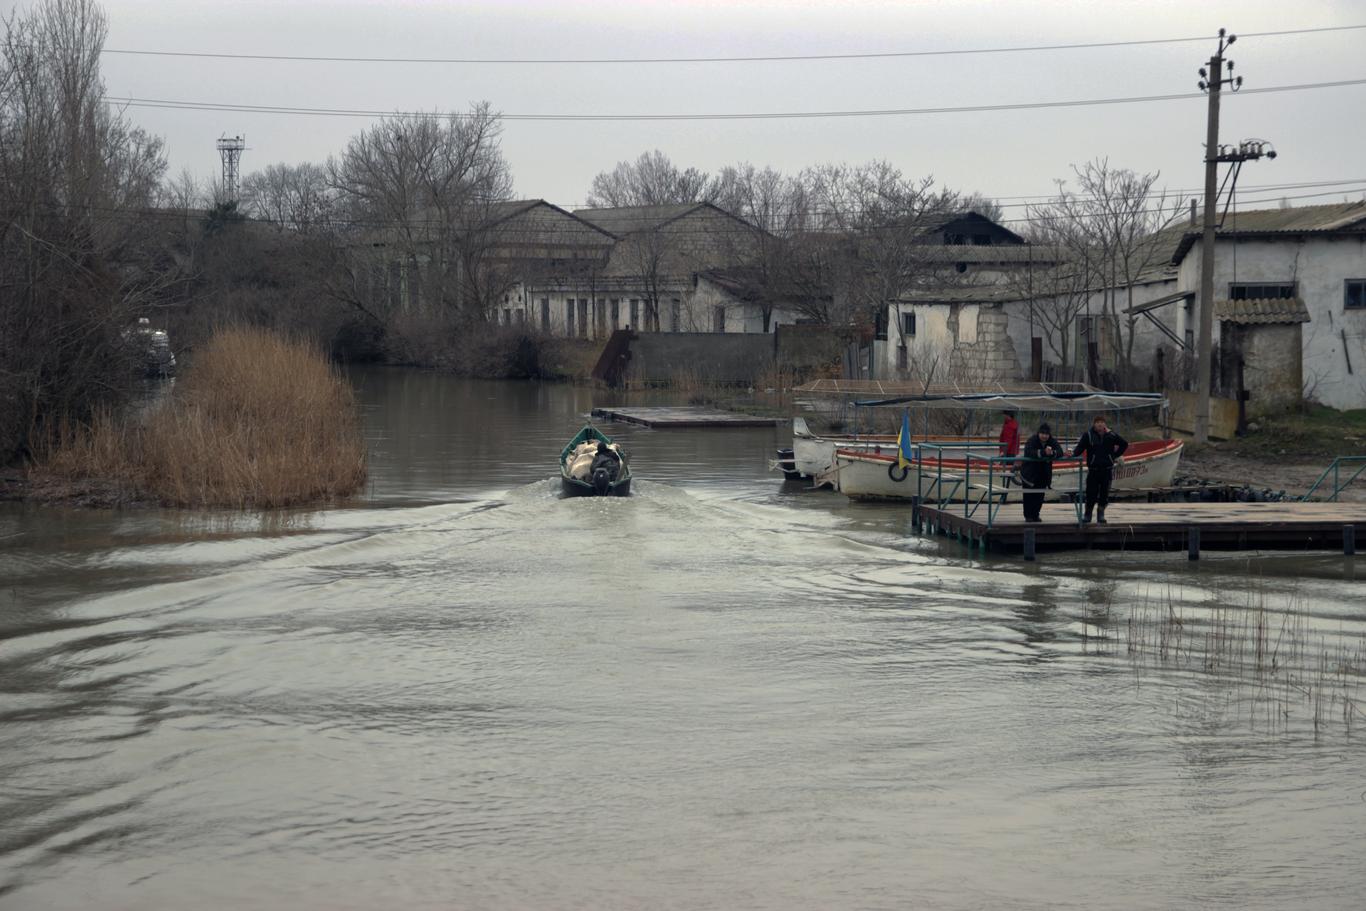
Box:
[102,25,1366,66]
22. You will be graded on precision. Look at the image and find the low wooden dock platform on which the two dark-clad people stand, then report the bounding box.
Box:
[911,501,1366,560]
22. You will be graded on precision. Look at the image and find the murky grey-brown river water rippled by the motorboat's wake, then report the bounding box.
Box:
[0,370,1366,911]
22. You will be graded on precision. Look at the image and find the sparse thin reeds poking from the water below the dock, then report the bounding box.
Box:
[1115,587,1366,735]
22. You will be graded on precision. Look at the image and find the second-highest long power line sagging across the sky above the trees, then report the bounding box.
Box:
[105,79,1366,123]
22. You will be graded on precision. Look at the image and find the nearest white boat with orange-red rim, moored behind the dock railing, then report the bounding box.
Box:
[818,440,1184,503]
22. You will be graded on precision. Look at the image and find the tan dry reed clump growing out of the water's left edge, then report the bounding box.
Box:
[36,328,365,508]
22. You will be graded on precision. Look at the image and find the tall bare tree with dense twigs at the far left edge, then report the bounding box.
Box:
[0,0,172,453]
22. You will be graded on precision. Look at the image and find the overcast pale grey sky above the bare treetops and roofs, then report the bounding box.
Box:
[8,0,1366,214]
